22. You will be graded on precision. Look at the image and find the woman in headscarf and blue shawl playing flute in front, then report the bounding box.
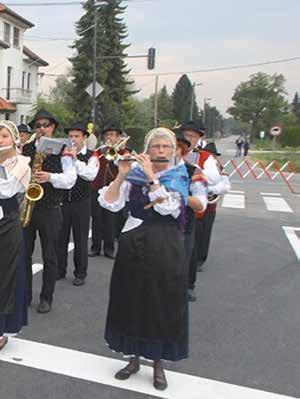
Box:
[99,128,189,390]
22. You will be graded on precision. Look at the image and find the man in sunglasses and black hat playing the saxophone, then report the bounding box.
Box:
[23,110,77,313]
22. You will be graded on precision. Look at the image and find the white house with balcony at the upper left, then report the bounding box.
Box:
[0,3,48,125]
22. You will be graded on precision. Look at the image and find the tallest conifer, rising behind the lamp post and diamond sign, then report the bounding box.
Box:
[70,0,133,126]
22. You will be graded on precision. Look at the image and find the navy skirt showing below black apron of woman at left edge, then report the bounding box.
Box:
[0,242,28,336]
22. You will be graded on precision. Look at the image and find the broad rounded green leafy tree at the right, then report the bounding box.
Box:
[227,72,288,137]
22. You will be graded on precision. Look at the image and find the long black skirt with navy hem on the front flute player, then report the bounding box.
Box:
[105,220,188,361]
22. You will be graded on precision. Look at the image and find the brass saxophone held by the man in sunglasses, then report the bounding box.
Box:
[21,152,46,227]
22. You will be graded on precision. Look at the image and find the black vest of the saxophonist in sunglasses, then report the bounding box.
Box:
[23,141,64,208]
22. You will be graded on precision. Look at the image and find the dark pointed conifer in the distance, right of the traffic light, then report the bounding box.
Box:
[172,75,200,123]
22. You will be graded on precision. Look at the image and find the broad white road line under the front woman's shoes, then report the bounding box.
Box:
[0,338,292,399]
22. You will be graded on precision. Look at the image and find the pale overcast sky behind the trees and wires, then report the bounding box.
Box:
[11,0,300,112]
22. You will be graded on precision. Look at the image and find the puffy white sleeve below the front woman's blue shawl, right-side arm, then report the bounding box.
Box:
[149,186,181,219]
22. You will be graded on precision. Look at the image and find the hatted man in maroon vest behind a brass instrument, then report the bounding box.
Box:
[89,125,122,259]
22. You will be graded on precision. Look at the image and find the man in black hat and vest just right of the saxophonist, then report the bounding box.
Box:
[57,123,99,286]
